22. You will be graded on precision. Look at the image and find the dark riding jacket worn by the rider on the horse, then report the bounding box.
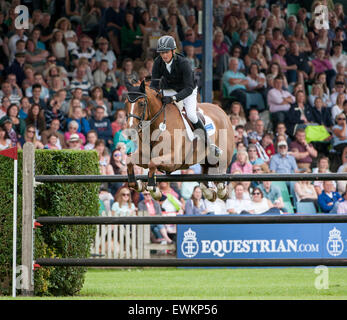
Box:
[150,53,196,101]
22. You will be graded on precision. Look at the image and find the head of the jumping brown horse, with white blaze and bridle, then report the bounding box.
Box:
[125,80,161,129]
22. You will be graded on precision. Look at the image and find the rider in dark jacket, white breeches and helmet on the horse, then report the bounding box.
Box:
[151,36,221,156]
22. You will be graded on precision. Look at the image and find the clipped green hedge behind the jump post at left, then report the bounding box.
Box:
[0,150,99,296]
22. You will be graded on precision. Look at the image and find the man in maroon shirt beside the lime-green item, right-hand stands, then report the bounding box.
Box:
[289,128,318,172]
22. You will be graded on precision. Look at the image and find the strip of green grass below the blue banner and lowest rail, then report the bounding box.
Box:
[0,268,347,300]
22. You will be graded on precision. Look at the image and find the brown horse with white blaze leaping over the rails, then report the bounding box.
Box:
[126,81,234,201]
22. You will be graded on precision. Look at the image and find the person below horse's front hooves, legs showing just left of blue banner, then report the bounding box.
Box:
[137,189,173,244]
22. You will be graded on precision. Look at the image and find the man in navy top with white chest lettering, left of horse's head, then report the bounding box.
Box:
[89,105,113,147]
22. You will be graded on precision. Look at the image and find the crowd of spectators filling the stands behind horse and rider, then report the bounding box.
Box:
[0,0,347,242]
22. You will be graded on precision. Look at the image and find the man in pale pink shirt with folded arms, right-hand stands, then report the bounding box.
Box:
[267,76,295,126]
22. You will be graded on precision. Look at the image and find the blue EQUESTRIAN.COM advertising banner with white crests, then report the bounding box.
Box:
[177,223,347,259]
